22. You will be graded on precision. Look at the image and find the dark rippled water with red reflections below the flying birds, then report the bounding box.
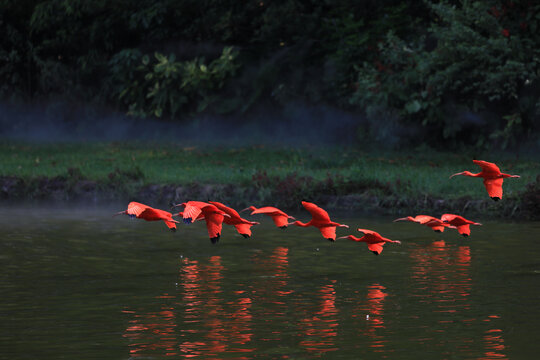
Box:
[0,208,540,359]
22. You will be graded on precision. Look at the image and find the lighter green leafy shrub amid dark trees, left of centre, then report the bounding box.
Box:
[109,47,239,118]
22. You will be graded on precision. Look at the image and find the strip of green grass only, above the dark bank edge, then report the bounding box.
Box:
[0,142,540,199]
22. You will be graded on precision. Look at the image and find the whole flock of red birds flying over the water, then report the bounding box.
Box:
[115,160,519,255]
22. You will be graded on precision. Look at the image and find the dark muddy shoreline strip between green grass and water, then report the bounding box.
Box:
[0,176,540,220]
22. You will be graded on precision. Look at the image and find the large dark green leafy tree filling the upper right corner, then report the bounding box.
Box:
[350,0,540,147]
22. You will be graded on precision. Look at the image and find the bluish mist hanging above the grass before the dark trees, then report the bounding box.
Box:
[0,102,363,146]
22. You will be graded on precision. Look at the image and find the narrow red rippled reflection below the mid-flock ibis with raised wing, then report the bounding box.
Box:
[300,280,339,354]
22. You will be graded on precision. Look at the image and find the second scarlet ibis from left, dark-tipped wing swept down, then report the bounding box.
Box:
[175,201,230,244]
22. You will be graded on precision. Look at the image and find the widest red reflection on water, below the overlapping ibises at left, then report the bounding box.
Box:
[124,256,255,359]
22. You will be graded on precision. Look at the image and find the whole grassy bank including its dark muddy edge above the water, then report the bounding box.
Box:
[0,142,540,217]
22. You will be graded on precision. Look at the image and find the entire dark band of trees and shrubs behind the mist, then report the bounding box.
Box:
[0,0,540,148]
